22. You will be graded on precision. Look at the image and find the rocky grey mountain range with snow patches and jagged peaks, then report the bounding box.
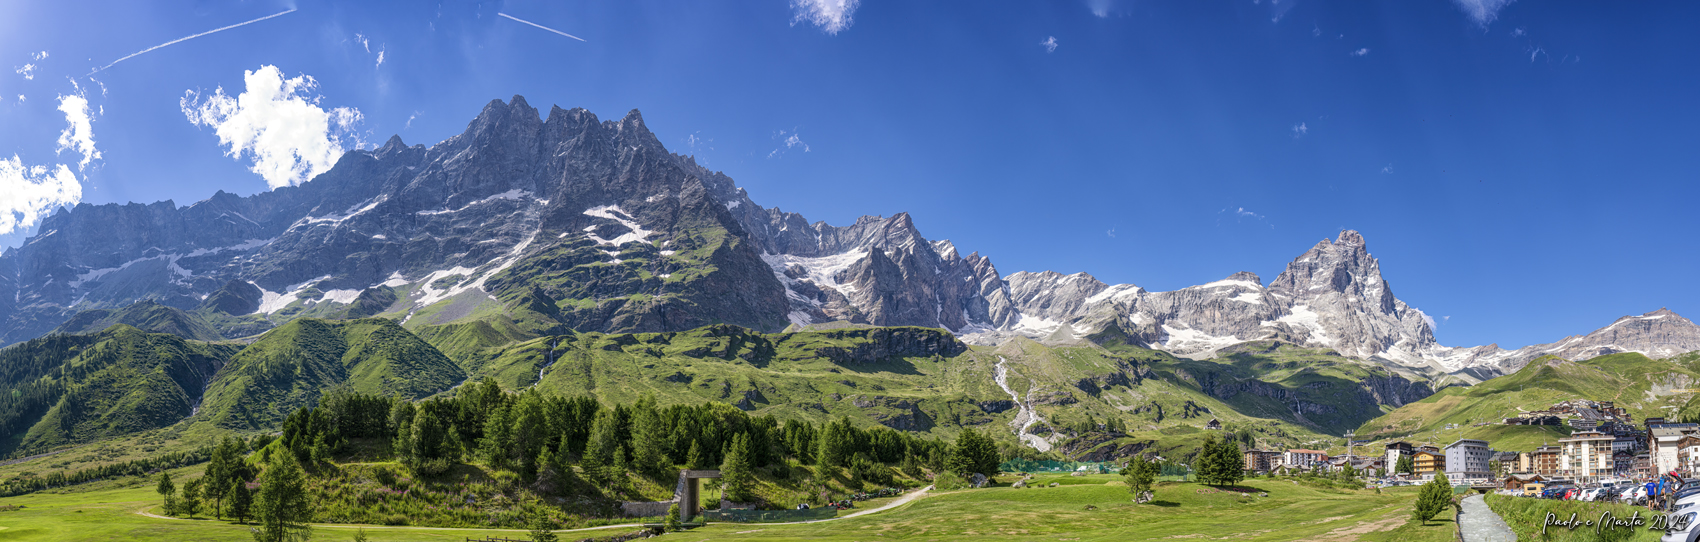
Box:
[0,97,1700,384]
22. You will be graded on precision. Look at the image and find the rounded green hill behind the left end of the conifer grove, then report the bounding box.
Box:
[194,318,466,430]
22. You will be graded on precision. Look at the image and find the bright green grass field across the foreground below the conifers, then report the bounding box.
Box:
[0,476,1454,542]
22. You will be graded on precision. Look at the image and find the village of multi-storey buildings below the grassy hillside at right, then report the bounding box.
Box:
[1244,399,1700,494]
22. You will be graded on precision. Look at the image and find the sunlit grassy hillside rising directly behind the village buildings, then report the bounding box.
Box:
[1358,352,1700,450]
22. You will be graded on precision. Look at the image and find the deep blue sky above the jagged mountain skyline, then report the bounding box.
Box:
[0,0,1700,347]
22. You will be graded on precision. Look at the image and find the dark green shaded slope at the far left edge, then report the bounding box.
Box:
[0,325,236,452]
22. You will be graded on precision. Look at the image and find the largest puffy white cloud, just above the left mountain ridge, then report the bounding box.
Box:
[179,66,362,189]
